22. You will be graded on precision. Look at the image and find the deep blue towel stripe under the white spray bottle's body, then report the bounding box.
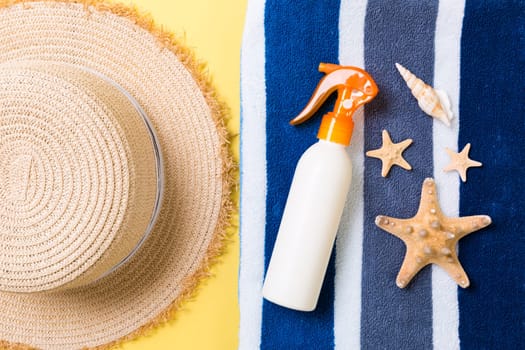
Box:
[261,0,339,350]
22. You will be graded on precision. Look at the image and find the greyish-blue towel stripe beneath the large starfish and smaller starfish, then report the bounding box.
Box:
[361,0,438,350]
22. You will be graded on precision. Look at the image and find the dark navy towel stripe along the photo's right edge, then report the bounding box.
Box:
[458,0,525,349]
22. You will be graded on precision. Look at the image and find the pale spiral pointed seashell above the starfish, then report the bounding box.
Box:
[396,63,453,126]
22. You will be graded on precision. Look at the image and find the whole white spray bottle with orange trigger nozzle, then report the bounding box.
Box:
[263,63,378,311]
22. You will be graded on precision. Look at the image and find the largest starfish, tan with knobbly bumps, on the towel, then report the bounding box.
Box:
[376,178,492,288]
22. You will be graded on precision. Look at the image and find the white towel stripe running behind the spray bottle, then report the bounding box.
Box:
[334,0,367,349]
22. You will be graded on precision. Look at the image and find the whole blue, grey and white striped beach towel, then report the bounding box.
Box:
[239,0,525,350]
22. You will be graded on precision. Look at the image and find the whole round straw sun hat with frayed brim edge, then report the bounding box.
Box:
[0,0,232,349]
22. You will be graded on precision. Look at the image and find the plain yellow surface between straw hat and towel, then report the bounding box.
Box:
[119,0,246,350]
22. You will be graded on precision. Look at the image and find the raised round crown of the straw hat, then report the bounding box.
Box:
[0,62,157,292]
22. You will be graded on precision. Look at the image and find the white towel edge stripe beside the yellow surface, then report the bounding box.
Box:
[239,0,266,350]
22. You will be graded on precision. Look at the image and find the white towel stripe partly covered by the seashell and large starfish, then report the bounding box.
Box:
[432,0,465,350]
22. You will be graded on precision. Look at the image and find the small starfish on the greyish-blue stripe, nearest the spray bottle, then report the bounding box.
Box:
[366,130,412,177]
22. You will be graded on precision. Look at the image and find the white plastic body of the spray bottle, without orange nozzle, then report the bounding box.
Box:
[263,140,352,311]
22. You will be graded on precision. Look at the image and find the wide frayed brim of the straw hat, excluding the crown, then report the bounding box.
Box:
[0,0,233,349]
